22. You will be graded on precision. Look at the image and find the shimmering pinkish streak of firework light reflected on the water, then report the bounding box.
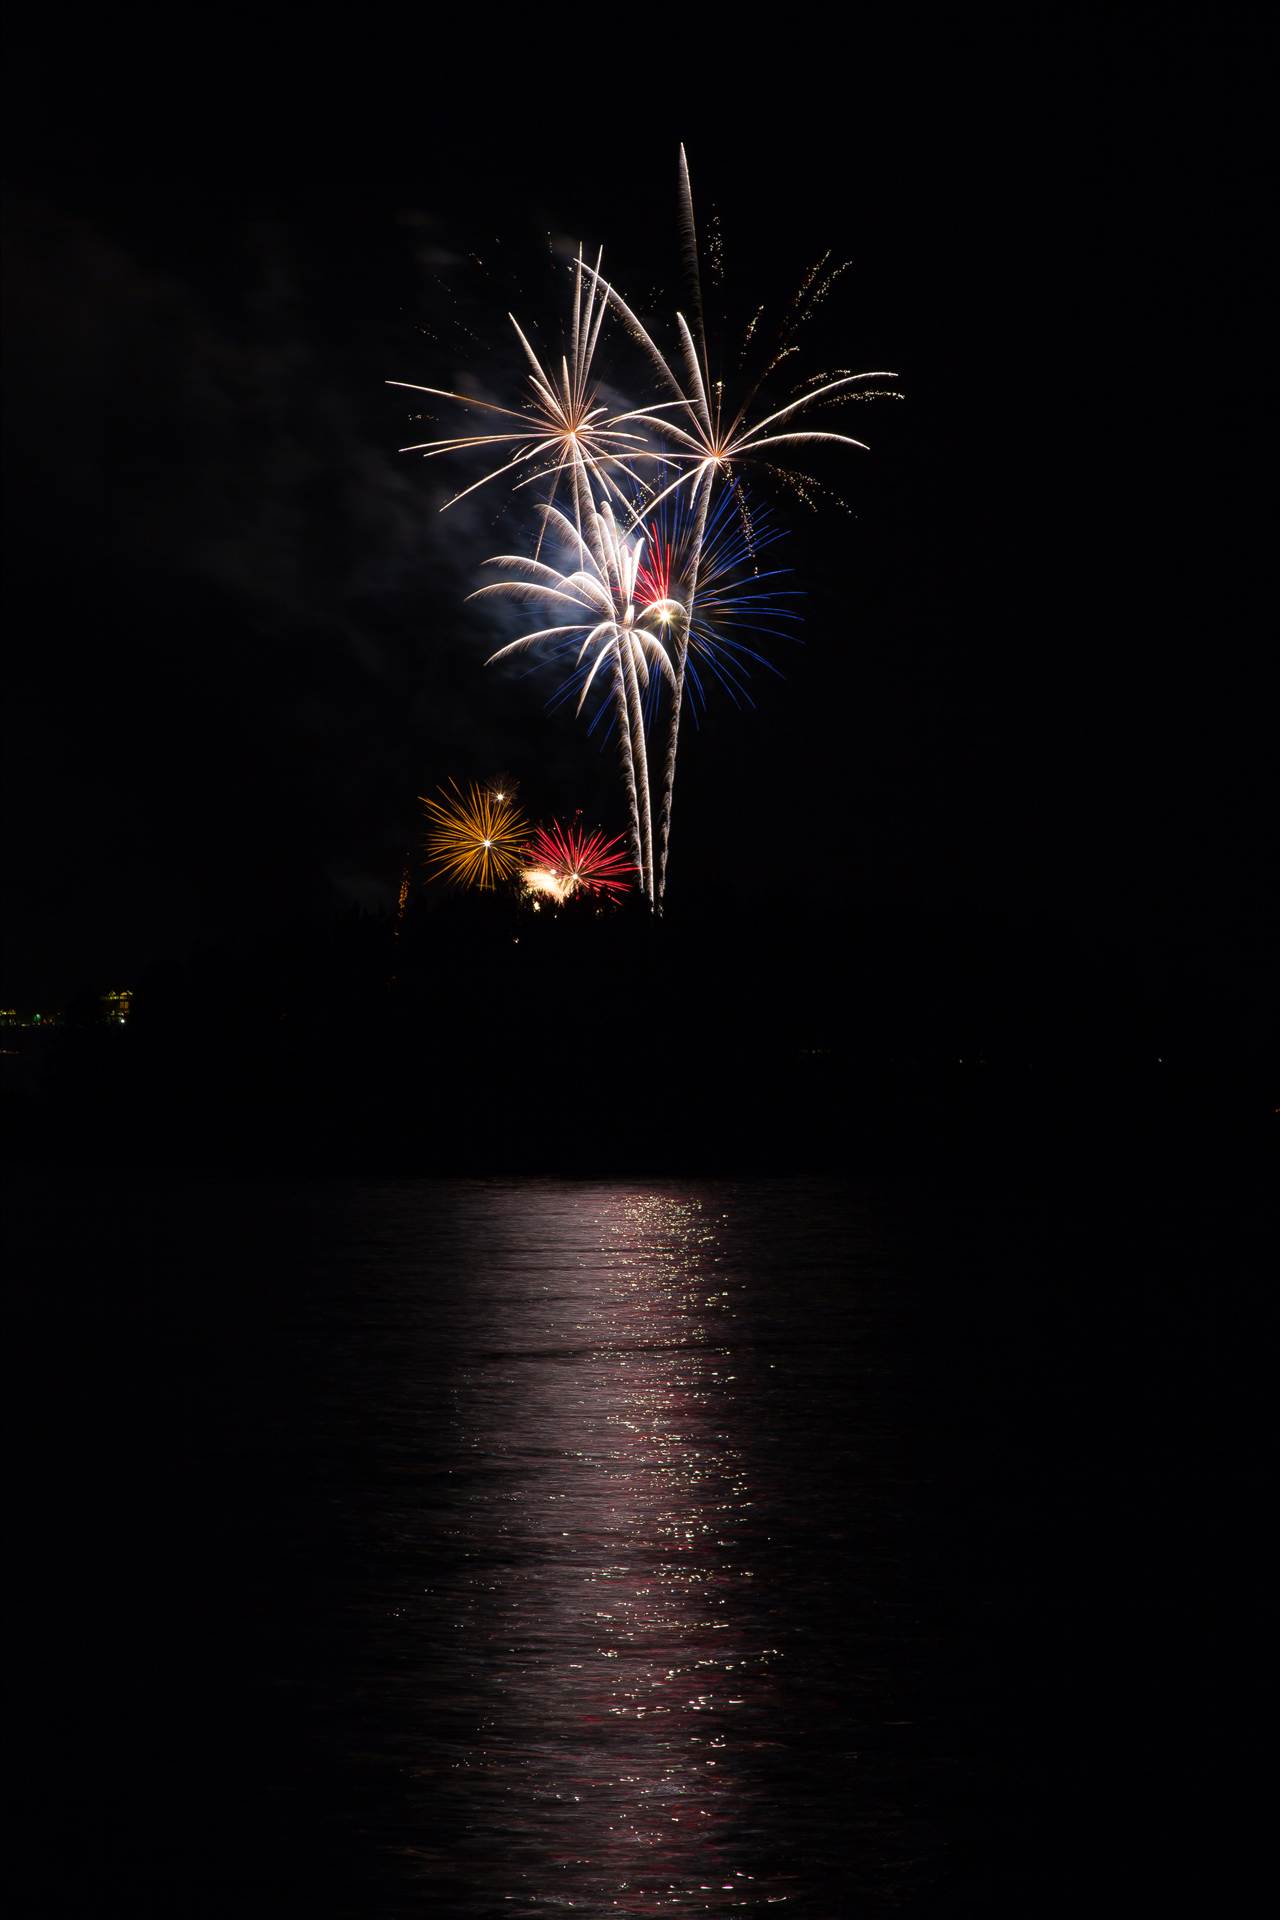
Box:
[434,1187,793,1914]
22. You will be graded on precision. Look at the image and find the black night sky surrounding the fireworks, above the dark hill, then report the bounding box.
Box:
[4,12,1278,1046]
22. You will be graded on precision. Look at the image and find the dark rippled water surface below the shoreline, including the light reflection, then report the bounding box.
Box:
[13,1175,1251,1920]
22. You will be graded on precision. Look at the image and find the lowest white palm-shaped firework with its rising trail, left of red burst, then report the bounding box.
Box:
[468,501,683,900]
